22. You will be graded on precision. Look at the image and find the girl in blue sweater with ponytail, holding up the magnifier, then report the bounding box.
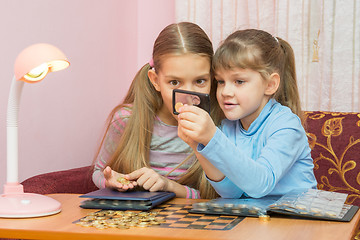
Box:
[179,29,317,198]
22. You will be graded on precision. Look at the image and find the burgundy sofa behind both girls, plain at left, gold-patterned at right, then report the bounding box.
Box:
[22,111,360,206]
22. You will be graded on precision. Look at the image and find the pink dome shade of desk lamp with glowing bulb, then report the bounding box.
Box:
[14,43,70,83]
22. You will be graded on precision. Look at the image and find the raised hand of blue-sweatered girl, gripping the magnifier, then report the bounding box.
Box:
[178,105,216,146]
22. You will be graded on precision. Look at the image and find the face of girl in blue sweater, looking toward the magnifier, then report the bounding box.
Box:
[215,68,270,130]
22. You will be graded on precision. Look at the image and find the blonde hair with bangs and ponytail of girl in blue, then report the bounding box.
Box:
[212,29,303,122]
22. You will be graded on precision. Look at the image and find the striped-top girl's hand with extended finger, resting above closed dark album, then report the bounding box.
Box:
[125,167,169,192]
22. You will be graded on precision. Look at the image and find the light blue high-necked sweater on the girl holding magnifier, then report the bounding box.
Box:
[198,99,317,198]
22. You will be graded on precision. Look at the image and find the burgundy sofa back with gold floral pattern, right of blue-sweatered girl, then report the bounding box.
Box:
[305,111,360,206]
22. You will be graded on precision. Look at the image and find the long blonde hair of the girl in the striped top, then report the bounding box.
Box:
[96,22,220,198]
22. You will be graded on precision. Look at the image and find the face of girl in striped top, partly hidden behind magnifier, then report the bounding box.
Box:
[148,53,211,125]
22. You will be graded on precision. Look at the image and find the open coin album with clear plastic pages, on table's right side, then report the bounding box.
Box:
[190,189,358,221]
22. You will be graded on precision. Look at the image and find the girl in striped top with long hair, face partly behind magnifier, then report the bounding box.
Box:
[93,22,220,198]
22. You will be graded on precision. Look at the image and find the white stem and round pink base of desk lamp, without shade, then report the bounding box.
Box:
[0,77,61,218]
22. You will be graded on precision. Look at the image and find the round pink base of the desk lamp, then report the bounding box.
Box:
[0,193,61,218]
